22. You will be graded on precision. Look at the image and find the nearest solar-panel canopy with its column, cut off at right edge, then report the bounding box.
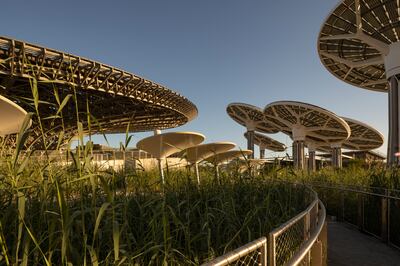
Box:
[318,0,400,165]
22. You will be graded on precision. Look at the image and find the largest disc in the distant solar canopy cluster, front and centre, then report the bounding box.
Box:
[264,101,350,144]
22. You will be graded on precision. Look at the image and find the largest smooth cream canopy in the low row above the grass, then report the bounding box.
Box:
[136,132,205,159]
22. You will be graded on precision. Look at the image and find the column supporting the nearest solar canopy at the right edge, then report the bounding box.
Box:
[387,76,400,166]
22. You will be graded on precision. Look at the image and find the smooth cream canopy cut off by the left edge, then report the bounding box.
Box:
[0,95,27,136]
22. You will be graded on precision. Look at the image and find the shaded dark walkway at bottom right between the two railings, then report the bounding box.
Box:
[328,222,400,266]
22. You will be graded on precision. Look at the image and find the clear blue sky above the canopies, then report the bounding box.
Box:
[0,0,388,156]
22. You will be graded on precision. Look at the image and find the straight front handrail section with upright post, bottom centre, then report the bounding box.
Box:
[203,237,267,266]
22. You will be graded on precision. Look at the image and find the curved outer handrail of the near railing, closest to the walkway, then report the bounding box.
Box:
[288,200,326,266]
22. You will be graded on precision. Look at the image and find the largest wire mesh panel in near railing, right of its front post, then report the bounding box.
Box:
[275,219,304,265]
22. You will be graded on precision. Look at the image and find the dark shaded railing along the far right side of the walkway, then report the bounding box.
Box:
[311,183,400,249]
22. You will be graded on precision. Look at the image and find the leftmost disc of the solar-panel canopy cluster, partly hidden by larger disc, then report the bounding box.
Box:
[226,103,279,133]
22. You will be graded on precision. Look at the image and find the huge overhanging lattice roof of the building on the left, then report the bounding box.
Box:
[0,37,197,149]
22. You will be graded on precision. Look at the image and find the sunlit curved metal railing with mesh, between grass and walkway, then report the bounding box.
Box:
[203,185,327,266]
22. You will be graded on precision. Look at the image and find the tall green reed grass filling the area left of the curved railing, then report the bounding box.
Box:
[0,79,308,265]
